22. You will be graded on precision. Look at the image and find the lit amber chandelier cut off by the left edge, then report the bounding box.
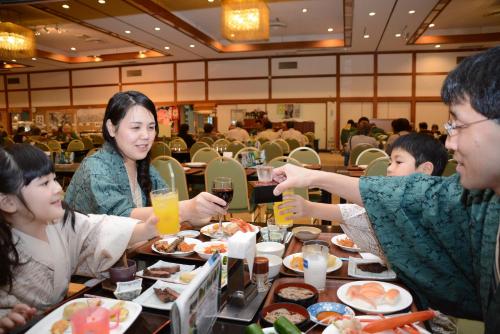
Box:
[0,22,35,59]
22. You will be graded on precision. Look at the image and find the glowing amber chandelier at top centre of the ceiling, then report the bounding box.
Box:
[221,0,269,41]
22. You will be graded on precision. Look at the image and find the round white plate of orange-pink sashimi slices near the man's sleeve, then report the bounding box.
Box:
[337,281,413,314]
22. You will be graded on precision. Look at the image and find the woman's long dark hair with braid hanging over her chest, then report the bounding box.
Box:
[102,91,158,206]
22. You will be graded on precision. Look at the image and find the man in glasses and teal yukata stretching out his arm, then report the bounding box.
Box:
[273,47,500,334]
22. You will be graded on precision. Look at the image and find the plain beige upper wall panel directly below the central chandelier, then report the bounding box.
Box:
[208,58,269,79]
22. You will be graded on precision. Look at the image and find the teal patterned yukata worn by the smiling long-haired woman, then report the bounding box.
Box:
[64,143,166,217]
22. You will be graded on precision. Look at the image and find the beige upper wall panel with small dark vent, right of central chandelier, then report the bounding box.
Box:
[271,56,337,76]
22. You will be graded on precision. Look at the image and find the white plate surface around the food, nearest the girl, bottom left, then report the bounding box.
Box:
[26,298,142,334]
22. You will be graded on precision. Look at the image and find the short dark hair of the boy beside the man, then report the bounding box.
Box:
[388,133,448,176]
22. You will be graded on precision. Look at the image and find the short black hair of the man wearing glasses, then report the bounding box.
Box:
[441,46,500,122]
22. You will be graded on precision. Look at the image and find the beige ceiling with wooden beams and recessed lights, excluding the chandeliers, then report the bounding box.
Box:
[0,0,500,71]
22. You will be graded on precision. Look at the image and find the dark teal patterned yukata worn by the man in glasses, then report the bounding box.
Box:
[360,174,500,333]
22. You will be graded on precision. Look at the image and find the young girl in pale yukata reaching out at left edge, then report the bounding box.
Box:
[0,144,157,324]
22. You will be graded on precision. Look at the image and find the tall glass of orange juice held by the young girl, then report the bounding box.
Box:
[151,187,180,235]
